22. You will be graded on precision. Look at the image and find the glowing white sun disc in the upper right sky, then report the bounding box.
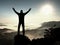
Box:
[40,4,53,15]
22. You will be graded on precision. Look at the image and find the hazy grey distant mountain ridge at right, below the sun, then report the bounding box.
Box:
[40,21,60,28]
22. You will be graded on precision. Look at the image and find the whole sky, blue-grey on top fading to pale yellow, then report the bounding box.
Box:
[0,0,60,30]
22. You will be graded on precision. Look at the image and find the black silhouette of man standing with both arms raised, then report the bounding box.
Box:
[12,8,31,35]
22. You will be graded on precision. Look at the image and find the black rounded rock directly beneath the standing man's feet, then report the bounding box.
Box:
[14,35,30,45]
